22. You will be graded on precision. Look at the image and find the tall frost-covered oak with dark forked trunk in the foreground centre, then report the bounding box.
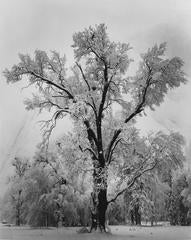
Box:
[4,24,186,229]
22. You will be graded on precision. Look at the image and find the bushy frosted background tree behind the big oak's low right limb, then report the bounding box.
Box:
[108,130,185,224]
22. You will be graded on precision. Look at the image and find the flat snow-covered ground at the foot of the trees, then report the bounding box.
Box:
[0,226,191,240]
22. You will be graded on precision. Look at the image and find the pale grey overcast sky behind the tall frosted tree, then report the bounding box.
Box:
[0,0,191,194]
